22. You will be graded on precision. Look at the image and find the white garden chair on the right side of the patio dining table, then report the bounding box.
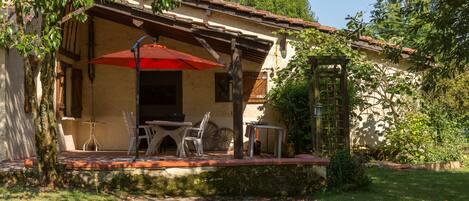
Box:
[181,112,210,156]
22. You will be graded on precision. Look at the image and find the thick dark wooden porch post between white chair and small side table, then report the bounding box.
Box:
[230,40,243,159]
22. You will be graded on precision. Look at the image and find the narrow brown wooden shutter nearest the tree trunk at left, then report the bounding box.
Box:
[55,62,67,118]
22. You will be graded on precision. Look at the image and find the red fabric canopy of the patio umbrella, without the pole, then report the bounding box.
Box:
[90,44,223,70]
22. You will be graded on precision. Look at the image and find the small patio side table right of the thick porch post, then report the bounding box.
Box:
[246,124,285,158]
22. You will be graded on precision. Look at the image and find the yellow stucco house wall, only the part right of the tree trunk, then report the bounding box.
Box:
[58,1,414,150]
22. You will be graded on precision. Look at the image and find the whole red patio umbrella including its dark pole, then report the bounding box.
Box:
[90,36,223,159]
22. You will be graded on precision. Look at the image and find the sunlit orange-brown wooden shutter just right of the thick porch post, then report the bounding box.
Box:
[243,72,267,103]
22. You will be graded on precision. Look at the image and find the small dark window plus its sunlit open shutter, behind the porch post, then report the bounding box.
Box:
[215,72,267,103]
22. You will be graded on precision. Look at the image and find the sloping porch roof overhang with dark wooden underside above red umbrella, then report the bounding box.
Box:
[87,2,273,63]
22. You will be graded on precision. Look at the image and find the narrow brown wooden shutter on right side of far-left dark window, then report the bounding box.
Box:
[71,69,83,118]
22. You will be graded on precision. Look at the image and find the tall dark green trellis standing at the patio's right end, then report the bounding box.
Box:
[309,56,350,155]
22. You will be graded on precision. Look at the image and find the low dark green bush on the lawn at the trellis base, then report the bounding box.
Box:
[327,150,371,190]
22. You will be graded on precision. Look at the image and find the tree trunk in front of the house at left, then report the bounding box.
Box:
[24,53,58,188]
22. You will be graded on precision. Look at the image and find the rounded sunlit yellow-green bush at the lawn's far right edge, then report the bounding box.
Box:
[385,107,465,164]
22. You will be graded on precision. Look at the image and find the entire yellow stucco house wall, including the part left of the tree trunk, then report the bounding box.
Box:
[0,2,416,160]
